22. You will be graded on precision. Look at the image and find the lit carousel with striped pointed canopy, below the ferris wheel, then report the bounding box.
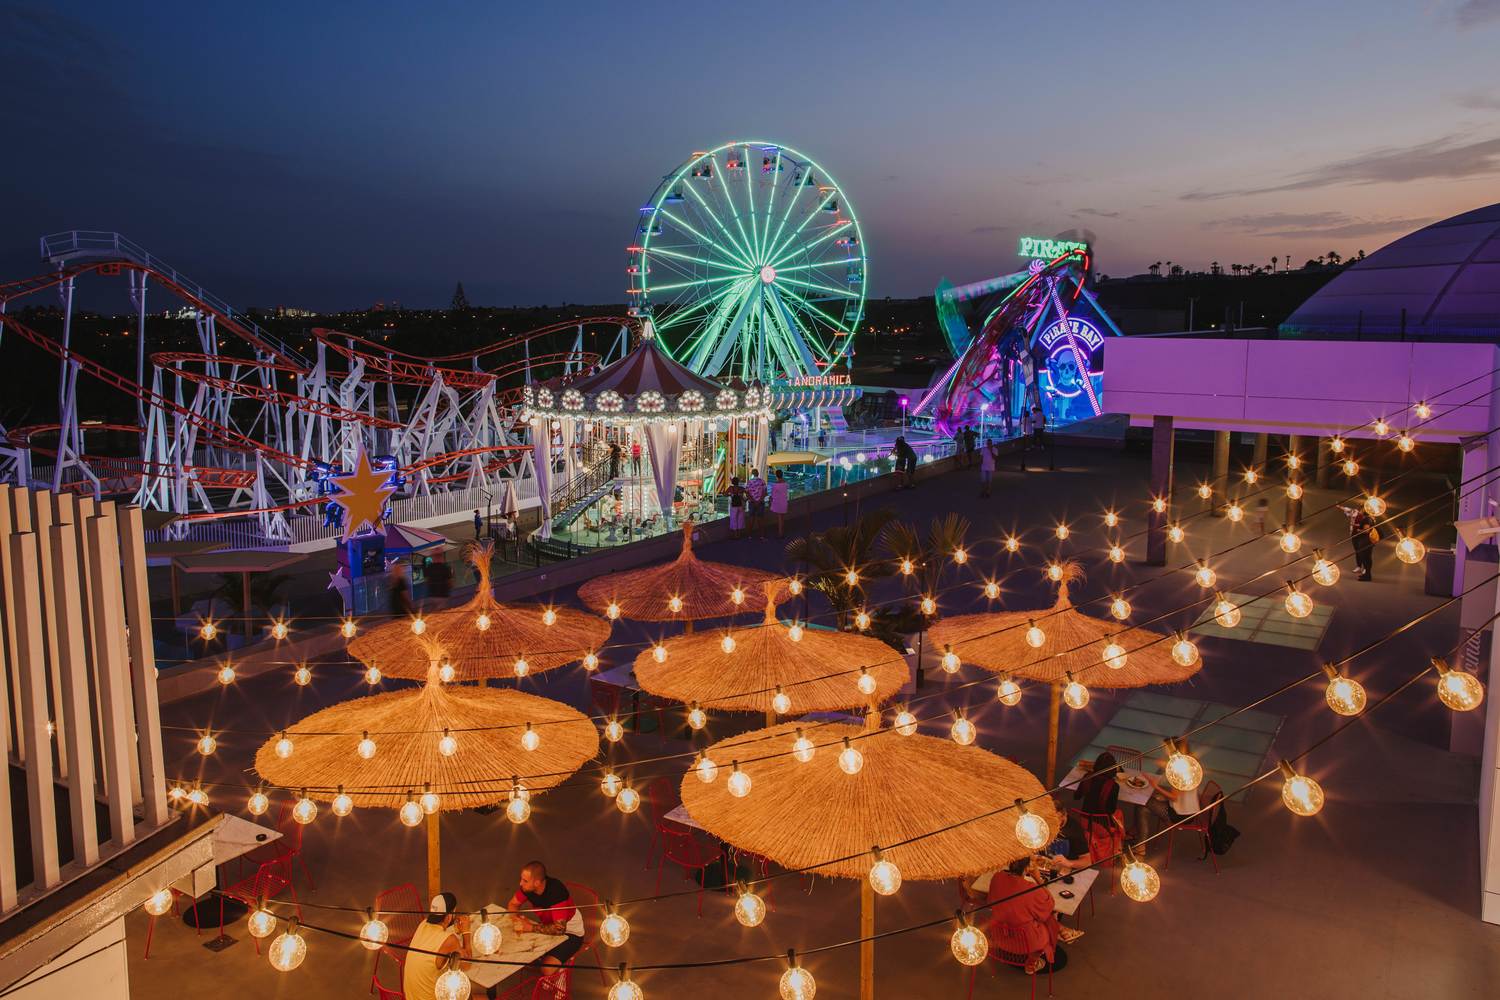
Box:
[522,319,773,547]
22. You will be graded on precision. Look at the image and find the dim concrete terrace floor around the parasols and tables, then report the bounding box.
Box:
[128,450,1500,1000]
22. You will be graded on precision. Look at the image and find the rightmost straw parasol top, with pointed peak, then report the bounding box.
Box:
[929,562,1203,688]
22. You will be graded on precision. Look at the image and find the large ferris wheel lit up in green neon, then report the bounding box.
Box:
[627,142,866,384]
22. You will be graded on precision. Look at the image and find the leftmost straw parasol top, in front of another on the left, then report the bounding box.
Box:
[255,682,599,810]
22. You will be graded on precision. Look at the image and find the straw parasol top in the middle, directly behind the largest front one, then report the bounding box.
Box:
[636,580,908,715]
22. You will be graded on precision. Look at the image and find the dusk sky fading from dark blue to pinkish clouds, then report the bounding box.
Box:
[0,0,1500,309]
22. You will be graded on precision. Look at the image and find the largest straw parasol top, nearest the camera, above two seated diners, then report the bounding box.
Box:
[683,724,1062,880]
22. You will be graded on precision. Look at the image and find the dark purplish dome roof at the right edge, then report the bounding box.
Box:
[1281,204,1500,340]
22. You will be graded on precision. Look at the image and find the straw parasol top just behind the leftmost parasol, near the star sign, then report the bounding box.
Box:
[350,543,609,681]
